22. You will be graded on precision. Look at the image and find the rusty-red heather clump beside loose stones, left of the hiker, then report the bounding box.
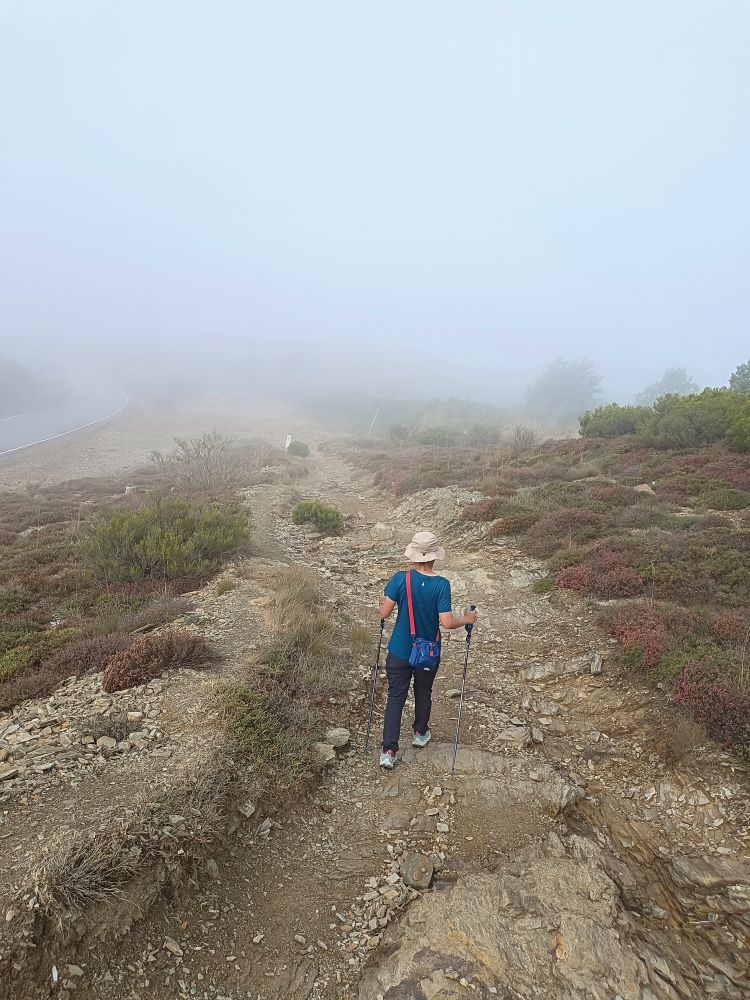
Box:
[102,631,214,691]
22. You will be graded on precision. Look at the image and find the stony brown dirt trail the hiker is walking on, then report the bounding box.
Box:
[0,452,750,1000]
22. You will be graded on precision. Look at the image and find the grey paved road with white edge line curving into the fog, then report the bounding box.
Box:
[0,376,128,456]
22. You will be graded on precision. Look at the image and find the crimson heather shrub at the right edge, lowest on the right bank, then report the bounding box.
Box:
[674,657,750,749]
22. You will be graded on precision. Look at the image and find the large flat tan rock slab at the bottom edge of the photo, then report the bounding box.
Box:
[358,834,649,1000]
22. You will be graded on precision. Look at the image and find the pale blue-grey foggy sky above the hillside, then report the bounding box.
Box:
[0,0,750,402]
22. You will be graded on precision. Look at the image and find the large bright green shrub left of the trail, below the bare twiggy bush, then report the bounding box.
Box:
[83,497,250,581]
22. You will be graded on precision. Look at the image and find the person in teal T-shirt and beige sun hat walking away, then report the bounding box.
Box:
[380,531,477,768]
